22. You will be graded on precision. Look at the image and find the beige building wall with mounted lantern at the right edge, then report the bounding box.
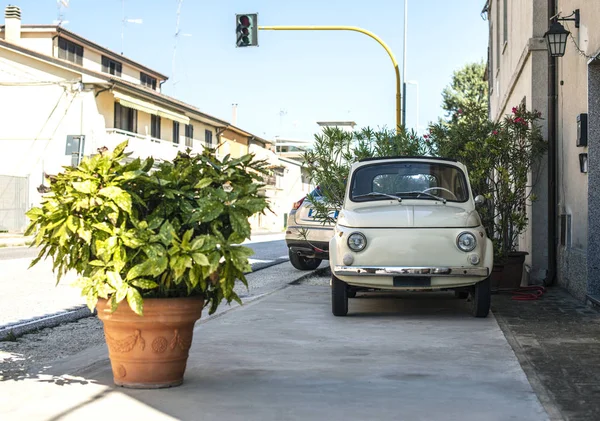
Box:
[484,0,600,300]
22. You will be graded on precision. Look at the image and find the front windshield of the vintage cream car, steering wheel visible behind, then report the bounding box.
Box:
[350,162,469,203]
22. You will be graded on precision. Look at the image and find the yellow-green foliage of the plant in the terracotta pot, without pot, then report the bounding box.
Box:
[26,142,268,315]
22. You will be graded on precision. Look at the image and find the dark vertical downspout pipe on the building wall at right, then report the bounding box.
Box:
[546,0,558,285]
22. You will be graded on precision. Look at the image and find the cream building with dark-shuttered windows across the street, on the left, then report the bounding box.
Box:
[0,6,288,232]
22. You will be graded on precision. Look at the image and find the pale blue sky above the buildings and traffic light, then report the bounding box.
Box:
[4,0,488,140]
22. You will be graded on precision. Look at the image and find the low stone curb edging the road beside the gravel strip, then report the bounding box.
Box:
[0,260,330,341]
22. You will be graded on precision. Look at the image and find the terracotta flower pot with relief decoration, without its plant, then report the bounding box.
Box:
[97,297,204,389]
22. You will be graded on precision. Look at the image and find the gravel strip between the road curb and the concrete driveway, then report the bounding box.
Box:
[0,262,329,381]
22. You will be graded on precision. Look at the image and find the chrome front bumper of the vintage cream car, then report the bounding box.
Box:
[334,265,490,277]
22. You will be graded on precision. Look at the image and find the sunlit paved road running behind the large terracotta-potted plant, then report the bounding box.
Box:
[0,234,288,327]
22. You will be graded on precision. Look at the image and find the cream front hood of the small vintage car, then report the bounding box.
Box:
[337,203,481,228]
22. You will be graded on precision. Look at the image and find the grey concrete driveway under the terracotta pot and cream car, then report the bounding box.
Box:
[0,278,548,421]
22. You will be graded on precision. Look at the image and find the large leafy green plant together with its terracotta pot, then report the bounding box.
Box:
[27,142,268,388]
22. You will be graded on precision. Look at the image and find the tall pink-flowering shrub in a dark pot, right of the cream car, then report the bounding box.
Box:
[424,102,547,288]
